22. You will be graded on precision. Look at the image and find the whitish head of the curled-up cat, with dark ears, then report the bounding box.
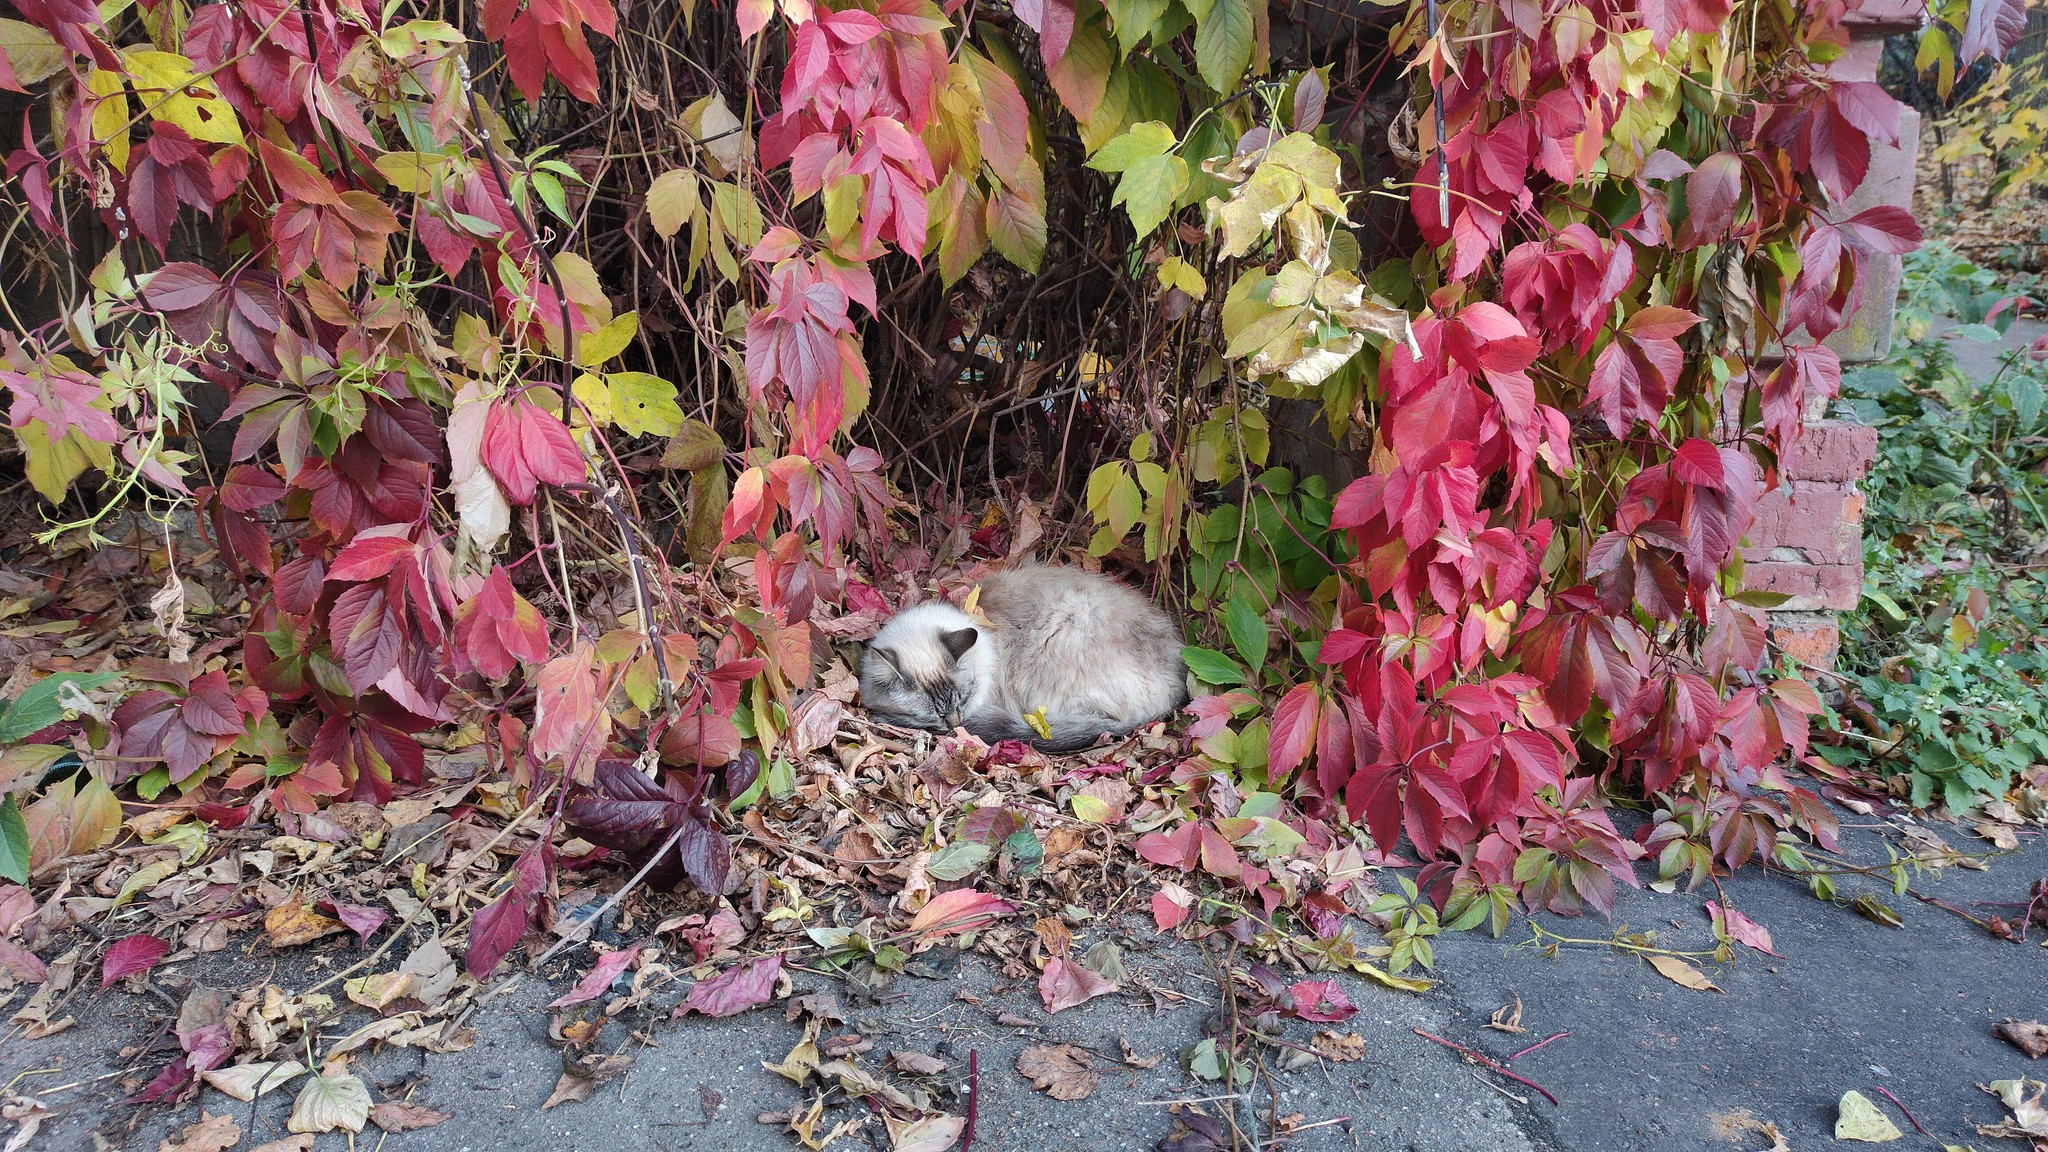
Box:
[860,605,987,732]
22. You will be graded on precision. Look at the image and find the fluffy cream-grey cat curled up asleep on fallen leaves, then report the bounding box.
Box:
[860,566,1188,752]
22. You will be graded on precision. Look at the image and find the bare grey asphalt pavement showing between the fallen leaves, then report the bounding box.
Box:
[0,815,2048,1152]
